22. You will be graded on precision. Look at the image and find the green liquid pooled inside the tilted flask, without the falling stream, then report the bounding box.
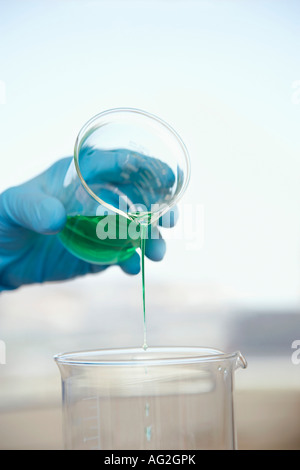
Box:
[60,215,140,264]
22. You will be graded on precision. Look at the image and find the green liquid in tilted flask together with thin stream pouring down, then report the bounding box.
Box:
[59,213,150,350]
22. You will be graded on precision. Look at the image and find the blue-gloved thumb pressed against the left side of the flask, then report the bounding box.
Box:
[0,186,67,235]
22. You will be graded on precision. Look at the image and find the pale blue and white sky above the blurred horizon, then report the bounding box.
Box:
[0,0,300,307]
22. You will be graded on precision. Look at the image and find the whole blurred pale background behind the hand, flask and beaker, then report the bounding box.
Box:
[0,0,300,449]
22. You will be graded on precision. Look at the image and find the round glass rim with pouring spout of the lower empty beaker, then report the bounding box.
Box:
[54,346,247,368]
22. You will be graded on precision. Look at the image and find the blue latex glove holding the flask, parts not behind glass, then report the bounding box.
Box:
[0,157,178,291]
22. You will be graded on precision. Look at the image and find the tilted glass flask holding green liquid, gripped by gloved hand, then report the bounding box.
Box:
[59,108,190,265]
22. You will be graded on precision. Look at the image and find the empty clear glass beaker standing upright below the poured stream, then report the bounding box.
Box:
[55,347,247,450]
